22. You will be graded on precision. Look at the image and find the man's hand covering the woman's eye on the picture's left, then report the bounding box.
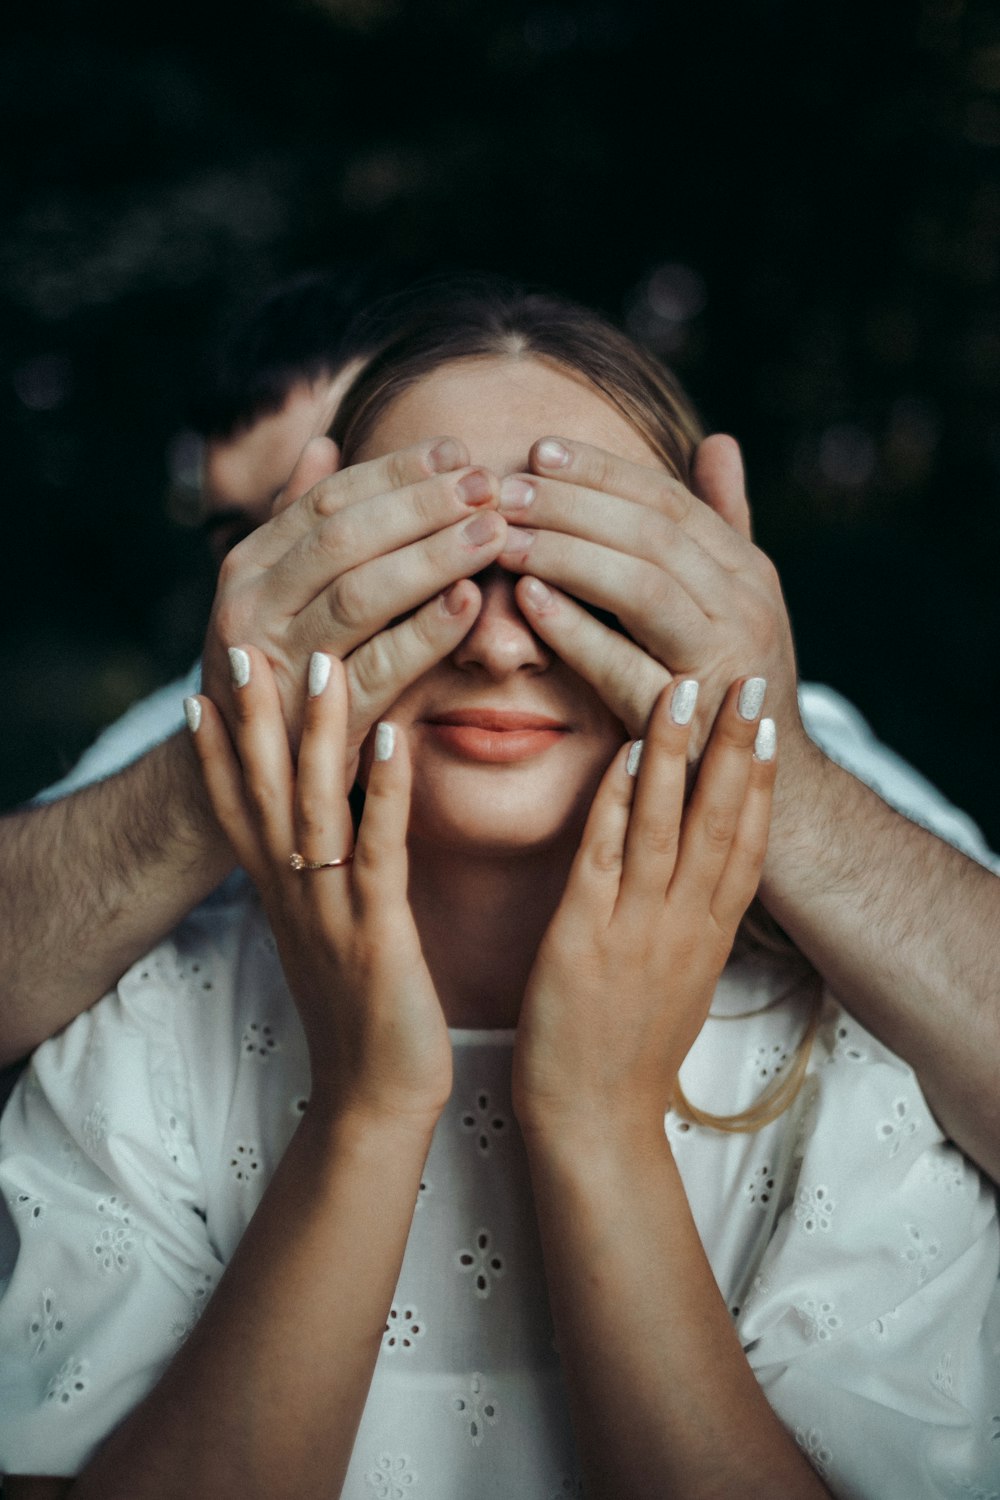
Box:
[202,438,507,786]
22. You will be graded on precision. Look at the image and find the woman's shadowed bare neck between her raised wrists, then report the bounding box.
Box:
[409,840,573,1028]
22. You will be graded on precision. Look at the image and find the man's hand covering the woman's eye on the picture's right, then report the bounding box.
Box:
[499,438,805,758]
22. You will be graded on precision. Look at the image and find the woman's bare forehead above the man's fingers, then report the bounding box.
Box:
[357,356,661,474]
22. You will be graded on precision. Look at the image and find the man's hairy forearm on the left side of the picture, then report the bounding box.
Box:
[0,734,232,1064]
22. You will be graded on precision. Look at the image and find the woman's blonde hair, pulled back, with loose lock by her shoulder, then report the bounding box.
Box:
[330,276,819,1131]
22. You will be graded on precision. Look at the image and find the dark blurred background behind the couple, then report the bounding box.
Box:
[0,0,1000,848]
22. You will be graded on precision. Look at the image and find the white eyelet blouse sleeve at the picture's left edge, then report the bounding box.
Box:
[0,944,222,1476]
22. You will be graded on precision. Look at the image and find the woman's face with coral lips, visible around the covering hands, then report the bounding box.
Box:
[357,357,661,855]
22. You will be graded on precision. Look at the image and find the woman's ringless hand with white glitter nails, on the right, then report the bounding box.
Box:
[514,678,775,1140]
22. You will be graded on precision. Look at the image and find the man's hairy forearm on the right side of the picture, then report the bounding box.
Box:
[760,746,1000,1181]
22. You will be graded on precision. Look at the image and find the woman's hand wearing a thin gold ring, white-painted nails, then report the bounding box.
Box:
[189,648,451,1124]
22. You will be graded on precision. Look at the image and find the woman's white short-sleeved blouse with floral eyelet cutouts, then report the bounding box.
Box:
[0,899,1000,1500]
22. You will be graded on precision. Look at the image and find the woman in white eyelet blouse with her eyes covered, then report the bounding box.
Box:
[0,283,997,1500]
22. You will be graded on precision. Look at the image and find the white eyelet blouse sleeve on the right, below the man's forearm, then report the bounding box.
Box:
[739,1016,1000,1500]
